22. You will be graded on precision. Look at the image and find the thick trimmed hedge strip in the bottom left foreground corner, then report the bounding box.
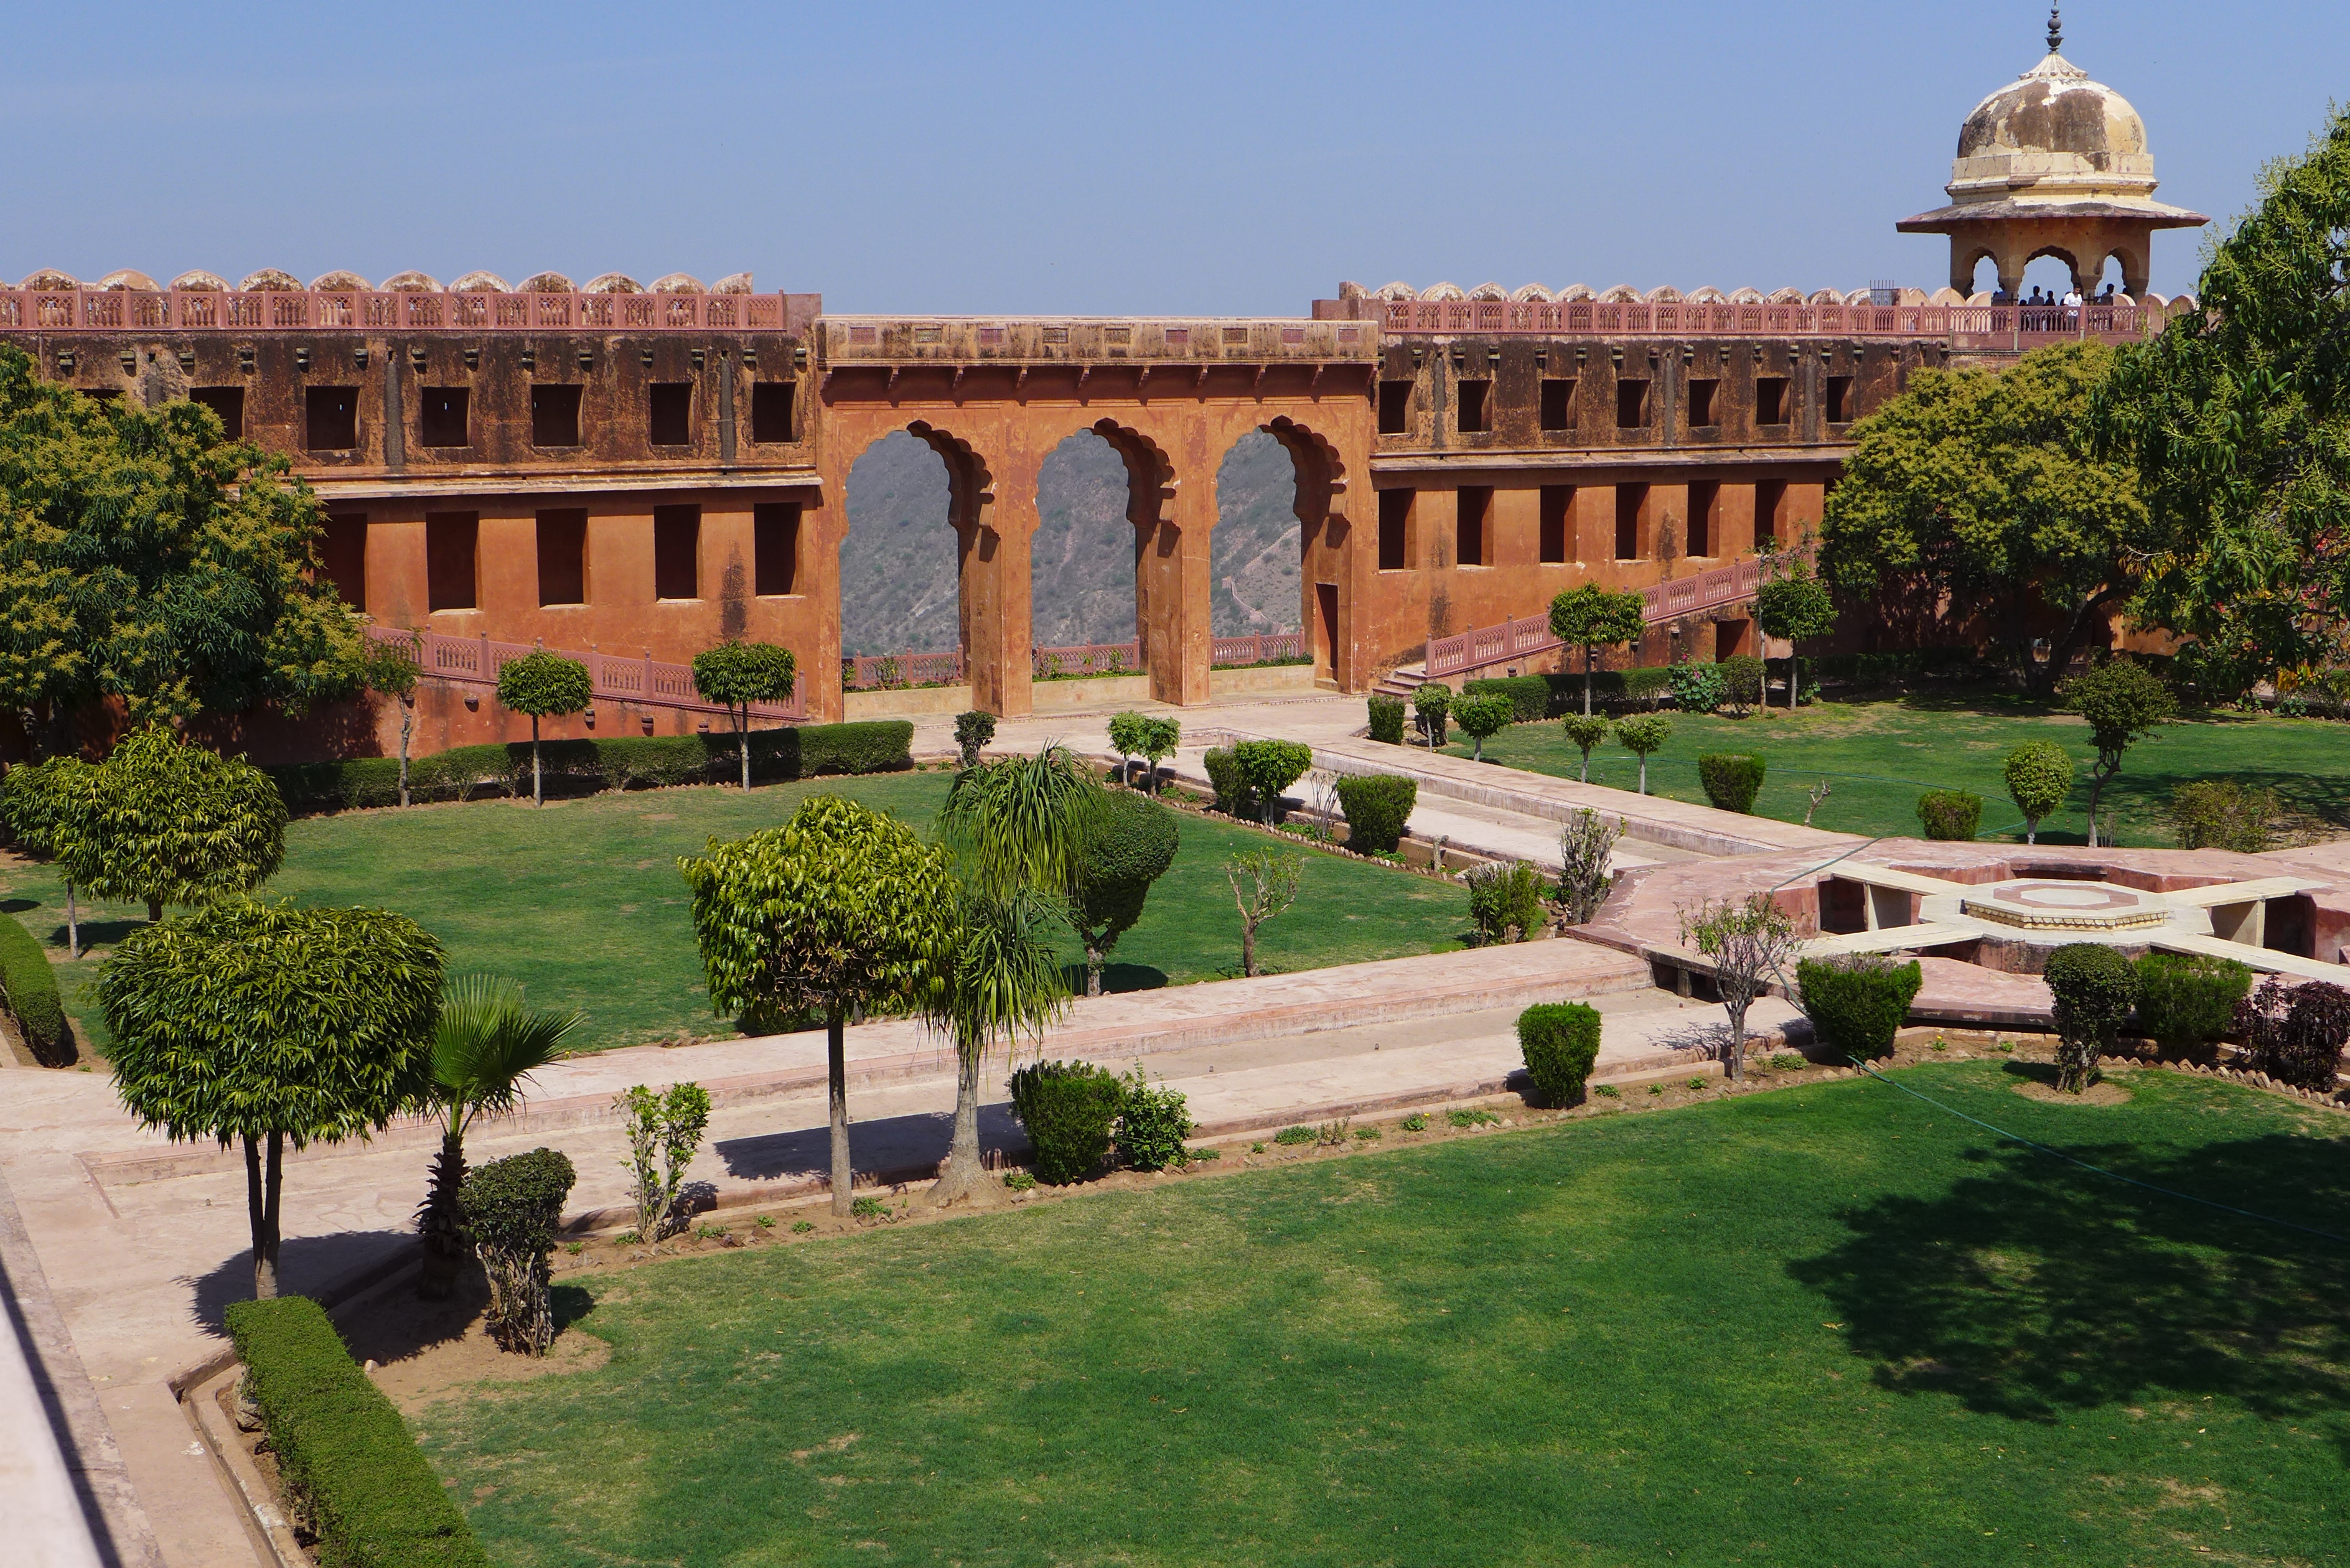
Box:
[228,1295,489,1568]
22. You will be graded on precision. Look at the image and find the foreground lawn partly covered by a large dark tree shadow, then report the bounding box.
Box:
[423,1063,2350,1568]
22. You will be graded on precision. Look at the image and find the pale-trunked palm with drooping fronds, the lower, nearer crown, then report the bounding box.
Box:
[929,886,1069,1206]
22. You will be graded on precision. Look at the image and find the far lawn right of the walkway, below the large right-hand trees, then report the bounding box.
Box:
[1450,691,2350,846]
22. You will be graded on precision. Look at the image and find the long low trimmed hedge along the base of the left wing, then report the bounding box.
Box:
[263,719,914,811]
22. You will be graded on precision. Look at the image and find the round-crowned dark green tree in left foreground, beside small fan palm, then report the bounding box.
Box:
[96,898,442,1298]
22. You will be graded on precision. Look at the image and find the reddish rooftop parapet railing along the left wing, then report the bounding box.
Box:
[0,289,820,332]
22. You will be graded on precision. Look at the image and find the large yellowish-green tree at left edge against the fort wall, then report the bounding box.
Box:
[0,345,362,750]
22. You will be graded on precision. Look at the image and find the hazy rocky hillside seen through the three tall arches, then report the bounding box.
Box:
[841,432,1299,653]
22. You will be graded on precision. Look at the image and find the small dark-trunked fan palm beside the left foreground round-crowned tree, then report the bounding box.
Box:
[416,976,581,1298]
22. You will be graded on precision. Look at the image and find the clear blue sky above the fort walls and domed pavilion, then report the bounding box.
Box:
[0,0,2350,315]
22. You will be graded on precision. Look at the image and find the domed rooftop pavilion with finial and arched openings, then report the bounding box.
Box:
[1894,7,2211,299]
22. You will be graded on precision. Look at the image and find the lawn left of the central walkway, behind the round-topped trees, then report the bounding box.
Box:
[0,773,1469,1048]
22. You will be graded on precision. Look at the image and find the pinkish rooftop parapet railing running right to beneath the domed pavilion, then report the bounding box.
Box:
[1384,299,2169,338]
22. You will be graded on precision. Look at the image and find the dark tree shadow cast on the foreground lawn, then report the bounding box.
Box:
[1789,1133,2350,1457]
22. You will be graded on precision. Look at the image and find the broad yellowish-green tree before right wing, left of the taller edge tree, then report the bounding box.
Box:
[1819,343,2169,694]
